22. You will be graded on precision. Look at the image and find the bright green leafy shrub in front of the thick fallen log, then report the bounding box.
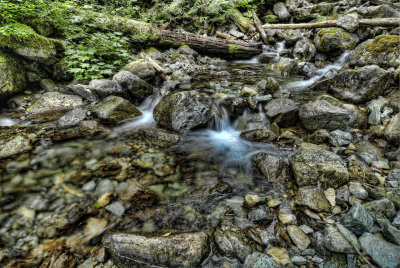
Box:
[65,32,133,80]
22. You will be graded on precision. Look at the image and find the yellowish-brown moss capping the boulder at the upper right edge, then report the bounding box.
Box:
[364,35,400,55]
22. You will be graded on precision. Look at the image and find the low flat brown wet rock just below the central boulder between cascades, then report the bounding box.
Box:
[139,128,181,148]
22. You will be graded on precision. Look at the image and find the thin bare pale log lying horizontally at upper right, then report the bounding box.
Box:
[263,18,400,29]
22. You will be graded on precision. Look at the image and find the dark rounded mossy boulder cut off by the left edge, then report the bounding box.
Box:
[0,51,26,98]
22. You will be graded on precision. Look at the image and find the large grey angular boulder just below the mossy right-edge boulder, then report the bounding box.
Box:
[321,65,394,103]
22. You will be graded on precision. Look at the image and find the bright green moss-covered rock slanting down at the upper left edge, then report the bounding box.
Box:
[0,23,57,65]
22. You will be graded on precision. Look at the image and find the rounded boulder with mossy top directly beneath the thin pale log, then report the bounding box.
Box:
[314,28,360,55]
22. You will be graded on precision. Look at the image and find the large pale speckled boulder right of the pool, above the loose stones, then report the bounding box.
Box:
[289,150,349,189]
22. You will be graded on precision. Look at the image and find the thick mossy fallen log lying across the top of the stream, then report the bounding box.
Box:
[73,9,262,59]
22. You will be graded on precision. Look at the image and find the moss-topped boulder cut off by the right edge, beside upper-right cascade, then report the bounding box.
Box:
[349,35,400,68]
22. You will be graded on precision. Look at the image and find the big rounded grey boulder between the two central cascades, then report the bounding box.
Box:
[153,90,213,131]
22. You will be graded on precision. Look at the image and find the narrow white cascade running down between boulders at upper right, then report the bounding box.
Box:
[286,52,349,91]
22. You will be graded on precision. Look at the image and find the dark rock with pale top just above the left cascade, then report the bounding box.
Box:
[113,71,153,100]
